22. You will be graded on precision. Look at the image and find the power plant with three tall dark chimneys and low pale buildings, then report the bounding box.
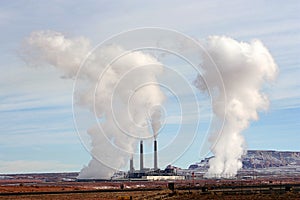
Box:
[127,138,185,180]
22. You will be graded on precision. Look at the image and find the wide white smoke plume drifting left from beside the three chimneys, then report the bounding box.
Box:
[23,31,165,178]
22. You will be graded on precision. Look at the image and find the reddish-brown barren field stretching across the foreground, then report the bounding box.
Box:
[0,180,300,200]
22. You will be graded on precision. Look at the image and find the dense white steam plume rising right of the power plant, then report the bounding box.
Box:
[195,36,277,177]
